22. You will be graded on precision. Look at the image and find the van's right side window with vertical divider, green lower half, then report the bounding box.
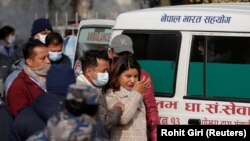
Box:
[187,36,250,101]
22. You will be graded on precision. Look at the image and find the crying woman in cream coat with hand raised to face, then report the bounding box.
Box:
[104,55,150,141]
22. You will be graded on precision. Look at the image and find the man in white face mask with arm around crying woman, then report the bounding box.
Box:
[76,50,124,130]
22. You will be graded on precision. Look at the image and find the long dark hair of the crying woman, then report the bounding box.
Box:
[103,54,141,93]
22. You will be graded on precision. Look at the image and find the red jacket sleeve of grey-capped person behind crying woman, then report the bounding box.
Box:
[141,70,160,141]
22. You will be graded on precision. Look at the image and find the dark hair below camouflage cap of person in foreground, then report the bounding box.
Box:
[65,100,99,116]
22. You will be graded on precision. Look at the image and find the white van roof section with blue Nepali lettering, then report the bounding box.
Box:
[114,3,250,32]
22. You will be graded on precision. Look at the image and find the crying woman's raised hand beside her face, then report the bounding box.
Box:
[134,77,151,94]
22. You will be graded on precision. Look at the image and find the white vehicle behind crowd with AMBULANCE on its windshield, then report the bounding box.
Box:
[73,19,115,75]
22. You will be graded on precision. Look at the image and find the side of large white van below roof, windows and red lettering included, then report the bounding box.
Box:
[122,30,250,125]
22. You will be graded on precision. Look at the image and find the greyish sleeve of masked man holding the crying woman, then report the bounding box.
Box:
[98,94,122,131]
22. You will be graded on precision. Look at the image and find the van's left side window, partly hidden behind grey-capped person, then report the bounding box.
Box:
[123,31,181,96]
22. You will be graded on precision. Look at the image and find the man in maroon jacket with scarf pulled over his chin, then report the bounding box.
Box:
[7,39,50,117]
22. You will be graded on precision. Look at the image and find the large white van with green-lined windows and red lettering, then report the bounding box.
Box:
[111,3,250,125]
